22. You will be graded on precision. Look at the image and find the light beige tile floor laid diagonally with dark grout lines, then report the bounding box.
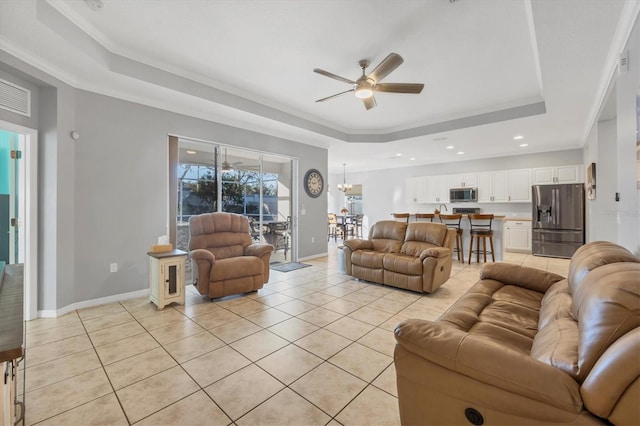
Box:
[25,244,569,425]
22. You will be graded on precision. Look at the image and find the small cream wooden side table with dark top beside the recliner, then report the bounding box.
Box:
[147,250,187,309]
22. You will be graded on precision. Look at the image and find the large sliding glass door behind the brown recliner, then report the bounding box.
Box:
[176,139,295,262]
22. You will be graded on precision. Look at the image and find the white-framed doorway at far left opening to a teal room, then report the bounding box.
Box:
[0,121,38,320]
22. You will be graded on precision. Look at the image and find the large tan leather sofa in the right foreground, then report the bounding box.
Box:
[395,241,640,425]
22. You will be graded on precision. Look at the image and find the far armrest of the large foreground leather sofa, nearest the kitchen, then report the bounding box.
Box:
[480,263,564,293]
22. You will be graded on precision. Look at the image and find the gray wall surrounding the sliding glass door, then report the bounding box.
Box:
[0,55,327,311]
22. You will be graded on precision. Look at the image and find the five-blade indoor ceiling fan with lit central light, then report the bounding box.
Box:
[313,53,424,110]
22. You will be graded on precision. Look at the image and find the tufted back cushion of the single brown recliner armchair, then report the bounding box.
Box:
[189,212,251,259]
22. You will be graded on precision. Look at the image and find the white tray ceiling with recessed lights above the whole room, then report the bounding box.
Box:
[0,0,640,173]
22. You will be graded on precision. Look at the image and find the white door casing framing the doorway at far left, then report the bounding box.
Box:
[0,120,38,320]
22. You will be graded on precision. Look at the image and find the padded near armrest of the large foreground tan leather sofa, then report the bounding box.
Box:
[395,319,582,413]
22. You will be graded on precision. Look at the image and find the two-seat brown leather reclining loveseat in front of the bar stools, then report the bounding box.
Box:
[344,220,456,293]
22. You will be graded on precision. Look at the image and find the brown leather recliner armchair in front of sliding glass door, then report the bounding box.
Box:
[189,213,273,298]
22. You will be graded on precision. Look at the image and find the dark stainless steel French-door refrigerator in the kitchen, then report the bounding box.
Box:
[531,184,584,258]
